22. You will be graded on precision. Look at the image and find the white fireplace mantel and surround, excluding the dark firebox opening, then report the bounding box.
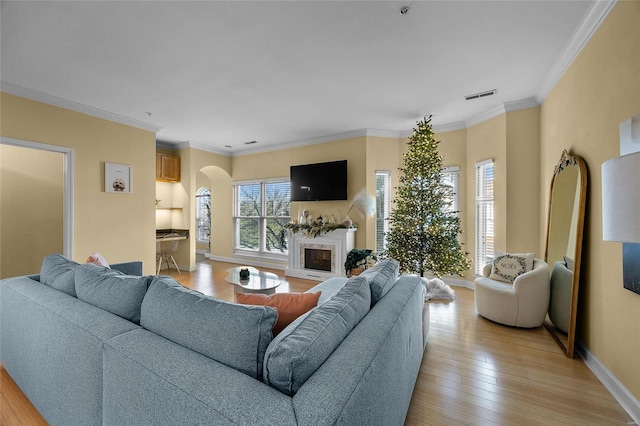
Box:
[285,228,356,280]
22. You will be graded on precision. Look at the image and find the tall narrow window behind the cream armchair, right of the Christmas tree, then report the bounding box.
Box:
[475,160,494,275]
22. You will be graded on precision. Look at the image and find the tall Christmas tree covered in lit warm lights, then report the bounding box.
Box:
[387,117,469,276]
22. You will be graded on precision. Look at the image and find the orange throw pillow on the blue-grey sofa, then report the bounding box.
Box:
[236,291,322,336]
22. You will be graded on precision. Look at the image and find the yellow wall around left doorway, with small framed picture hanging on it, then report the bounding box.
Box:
[0,93,155,273]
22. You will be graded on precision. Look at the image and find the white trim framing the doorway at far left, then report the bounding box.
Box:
[0,137,73,259]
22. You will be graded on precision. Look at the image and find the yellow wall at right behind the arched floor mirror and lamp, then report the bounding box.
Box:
[540,1,640,399]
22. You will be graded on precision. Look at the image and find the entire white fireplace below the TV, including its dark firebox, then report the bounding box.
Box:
[285,228,356,280]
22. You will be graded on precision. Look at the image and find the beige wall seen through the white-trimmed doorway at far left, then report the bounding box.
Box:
[0,145,64,278]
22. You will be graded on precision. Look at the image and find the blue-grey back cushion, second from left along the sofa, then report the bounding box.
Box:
[75,263,152,324]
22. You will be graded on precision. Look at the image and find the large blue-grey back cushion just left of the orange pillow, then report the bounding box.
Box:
[140,276,278,379]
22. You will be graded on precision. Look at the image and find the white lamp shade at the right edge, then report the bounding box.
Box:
[602,152,640,243]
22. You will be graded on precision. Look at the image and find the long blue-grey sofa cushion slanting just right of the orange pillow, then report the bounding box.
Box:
[263,276,371,396]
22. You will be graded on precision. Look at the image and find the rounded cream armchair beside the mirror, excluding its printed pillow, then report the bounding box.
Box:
[474,259,550,328]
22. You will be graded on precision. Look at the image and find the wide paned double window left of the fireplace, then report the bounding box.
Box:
[233,180,291,254]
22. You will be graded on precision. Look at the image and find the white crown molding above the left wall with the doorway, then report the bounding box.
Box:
[0,81,162,133]
